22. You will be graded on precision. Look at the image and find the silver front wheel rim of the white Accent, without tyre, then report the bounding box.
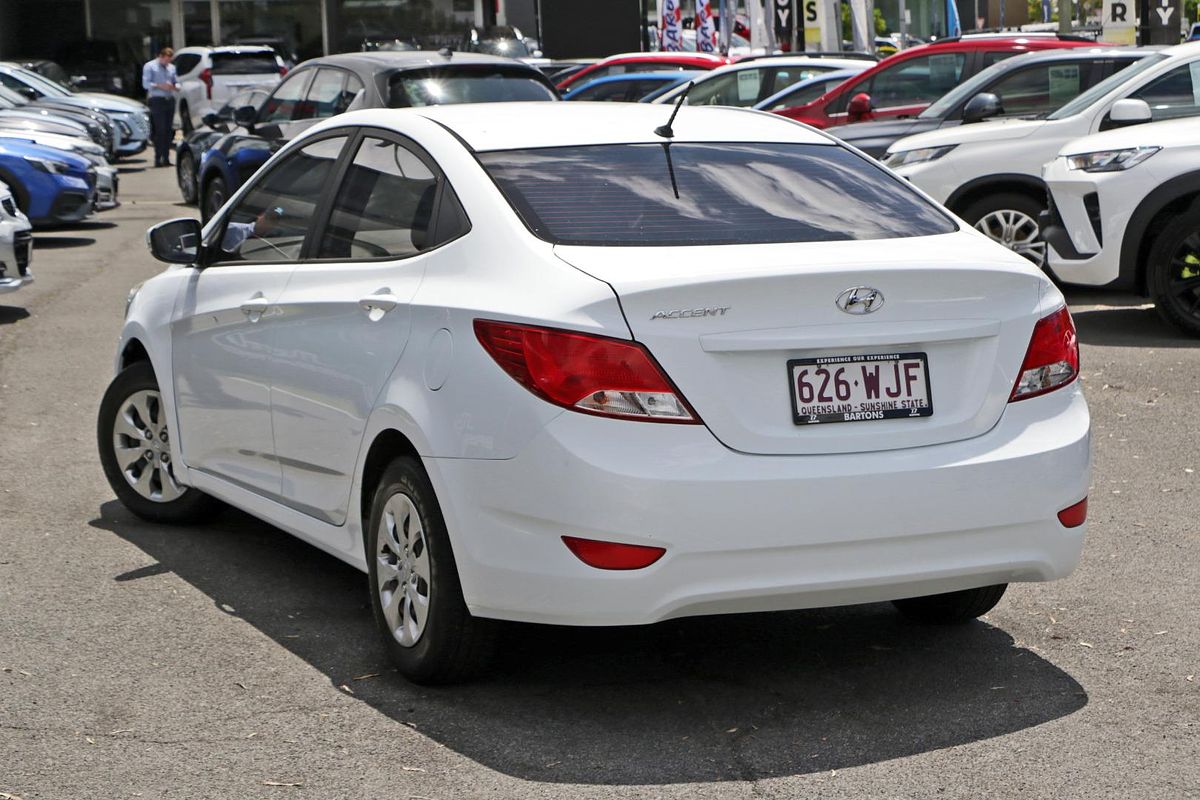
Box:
[113,390,184,503]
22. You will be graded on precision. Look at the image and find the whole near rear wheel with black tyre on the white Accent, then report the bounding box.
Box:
[364,457,497,685]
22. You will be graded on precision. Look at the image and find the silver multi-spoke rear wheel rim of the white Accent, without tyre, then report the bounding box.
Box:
[376,493,431,648]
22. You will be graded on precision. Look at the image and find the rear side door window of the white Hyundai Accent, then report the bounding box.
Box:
[318,137,438,259]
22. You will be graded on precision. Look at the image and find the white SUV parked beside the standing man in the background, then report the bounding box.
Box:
[174,44,287,136]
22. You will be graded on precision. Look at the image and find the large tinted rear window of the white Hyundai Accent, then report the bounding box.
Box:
[479,142,956,246]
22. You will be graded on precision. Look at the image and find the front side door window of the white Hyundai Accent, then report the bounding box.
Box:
[217,137,346,264]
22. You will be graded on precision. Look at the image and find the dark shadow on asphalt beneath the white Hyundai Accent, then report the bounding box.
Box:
[91,501,1087,786]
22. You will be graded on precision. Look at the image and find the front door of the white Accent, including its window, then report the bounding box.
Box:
[170,134,347,498]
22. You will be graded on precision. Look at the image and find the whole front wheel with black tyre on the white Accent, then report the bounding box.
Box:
[96,361,221,524]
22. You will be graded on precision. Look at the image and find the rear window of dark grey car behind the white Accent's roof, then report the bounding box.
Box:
[388,65,557,108]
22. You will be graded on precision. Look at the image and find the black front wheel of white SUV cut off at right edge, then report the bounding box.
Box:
[1146,210,1200,336]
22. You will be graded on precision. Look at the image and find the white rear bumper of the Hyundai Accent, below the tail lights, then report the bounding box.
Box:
[426,386,1090,625]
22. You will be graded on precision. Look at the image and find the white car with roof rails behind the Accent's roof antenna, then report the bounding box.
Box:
[654,55,871,108]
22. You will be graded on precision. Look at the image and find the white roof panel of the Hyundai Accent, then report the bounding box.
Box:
[405,101,836,152]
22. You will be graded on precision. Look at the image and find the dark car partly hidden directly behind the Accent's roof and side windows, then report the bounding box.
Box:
[197,49,558,219]
